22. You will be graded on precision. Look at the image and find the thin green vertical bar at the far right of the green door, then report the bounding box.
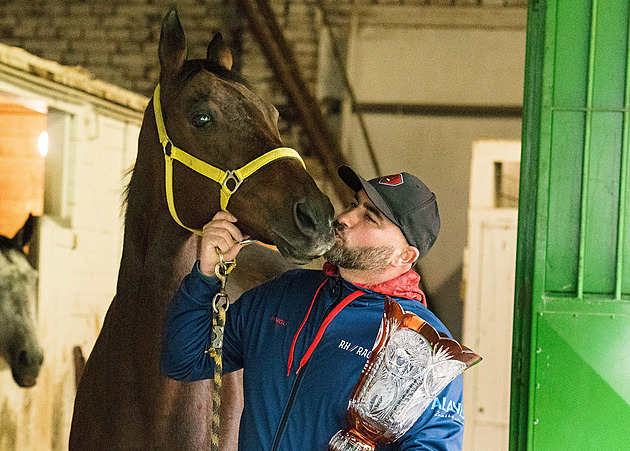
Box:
[615,10,630,301]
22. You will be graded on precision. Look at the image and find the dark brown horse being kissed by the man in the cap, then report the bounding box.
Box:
[70,10,333,450]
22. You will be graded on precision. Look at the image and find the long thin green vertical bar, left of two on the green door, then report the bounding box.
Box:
[576,0,597,300]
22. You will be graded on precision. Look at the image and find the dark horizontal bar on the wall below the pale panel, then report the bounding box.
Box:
[354,103,523,118]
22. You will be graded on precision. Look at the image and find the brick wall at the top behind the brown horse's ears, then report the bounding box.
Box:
[0,0,527,99]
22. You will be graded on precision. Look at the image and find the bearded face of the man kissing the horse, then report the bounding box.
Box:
[324,190,406,271]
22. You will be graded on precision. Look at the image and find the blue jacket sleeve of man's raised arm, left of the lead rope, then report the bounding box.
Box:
[160,262,221,382]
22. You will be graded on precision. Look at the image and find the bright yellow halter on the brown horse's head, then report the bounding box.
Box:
[153,84,306,235]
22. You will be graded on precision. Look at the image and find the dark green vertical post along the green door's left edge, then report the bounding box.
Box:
[509,2,554,450]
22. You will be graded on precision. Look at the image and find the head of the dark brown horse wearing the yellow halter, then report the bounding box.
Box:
[154,10,334,263]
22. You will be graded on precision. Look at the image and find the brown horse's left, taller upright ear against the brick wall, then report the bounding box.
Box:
[158,8,186,78]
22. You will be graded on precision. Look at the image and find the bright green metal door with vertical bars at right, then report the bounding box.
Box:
[510,0,630,451]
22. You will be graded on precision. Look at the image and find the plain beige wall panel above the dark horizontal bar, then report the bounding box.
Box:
[353,27,525,105]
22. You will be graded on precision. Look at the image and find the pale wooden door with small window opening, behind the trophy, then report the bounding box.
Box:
[462,141,521,451]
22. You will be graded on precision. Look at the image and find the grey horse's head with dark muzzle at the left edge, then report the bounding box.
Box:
[0,215,44,388]
